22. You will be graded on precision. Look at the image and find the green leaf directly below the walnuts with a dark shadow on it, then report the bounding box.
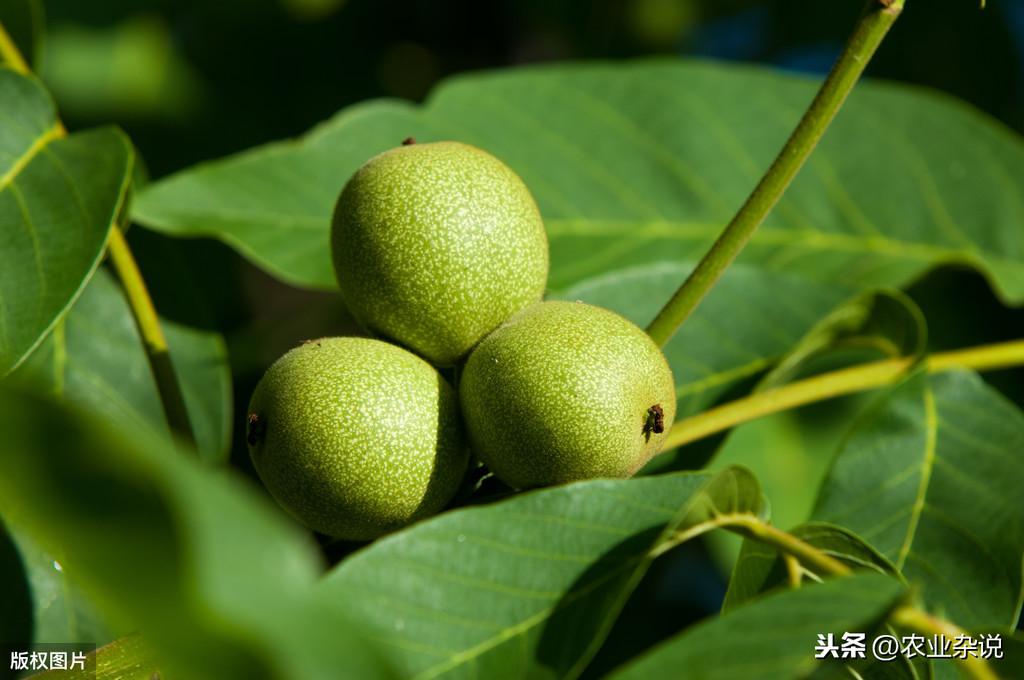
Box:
[321,468,761,678]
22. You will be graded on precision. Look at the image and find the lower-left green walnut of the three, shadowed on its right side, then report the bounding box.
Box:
[248,338,469,541]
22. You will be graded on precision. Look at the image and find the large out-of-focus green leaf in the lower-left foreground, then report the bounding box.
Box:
[0,389,389,680]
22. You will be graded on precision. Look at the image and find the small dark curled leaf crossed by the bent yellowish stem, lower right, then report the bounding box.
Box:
[722,522,900,611]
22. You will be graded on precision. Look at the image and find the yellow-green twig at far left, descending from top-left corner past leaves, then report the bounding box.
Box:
[0,17,196,443]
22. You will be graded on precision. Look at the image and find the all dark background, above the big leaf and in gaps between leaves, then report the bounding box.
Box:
[22,0,1024,672]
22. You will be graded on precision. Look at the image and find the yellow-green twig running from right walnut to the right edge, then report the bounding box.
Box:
[663,340,1024,451]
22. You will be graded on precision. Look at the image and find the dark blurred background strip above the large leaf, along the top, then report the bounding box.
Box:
[28,0,1024,176]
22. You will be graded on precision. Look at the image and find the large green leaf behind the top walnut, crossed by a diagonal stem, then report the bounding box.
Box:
[134,60,1024,304]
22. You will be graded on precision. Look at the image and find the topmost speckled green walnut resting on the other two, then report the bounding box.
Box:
[331,141,548,366]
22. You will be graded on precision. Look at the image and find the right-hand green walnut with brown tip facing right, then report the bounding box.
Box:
[460,302,676,488]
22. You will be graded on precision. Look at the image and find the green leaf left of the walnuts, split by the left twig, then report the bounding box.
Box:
[10,270,231,460]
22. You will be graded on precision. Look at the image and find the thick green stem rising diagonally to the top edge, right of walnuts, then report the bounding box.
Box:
[647,0,904,345]
